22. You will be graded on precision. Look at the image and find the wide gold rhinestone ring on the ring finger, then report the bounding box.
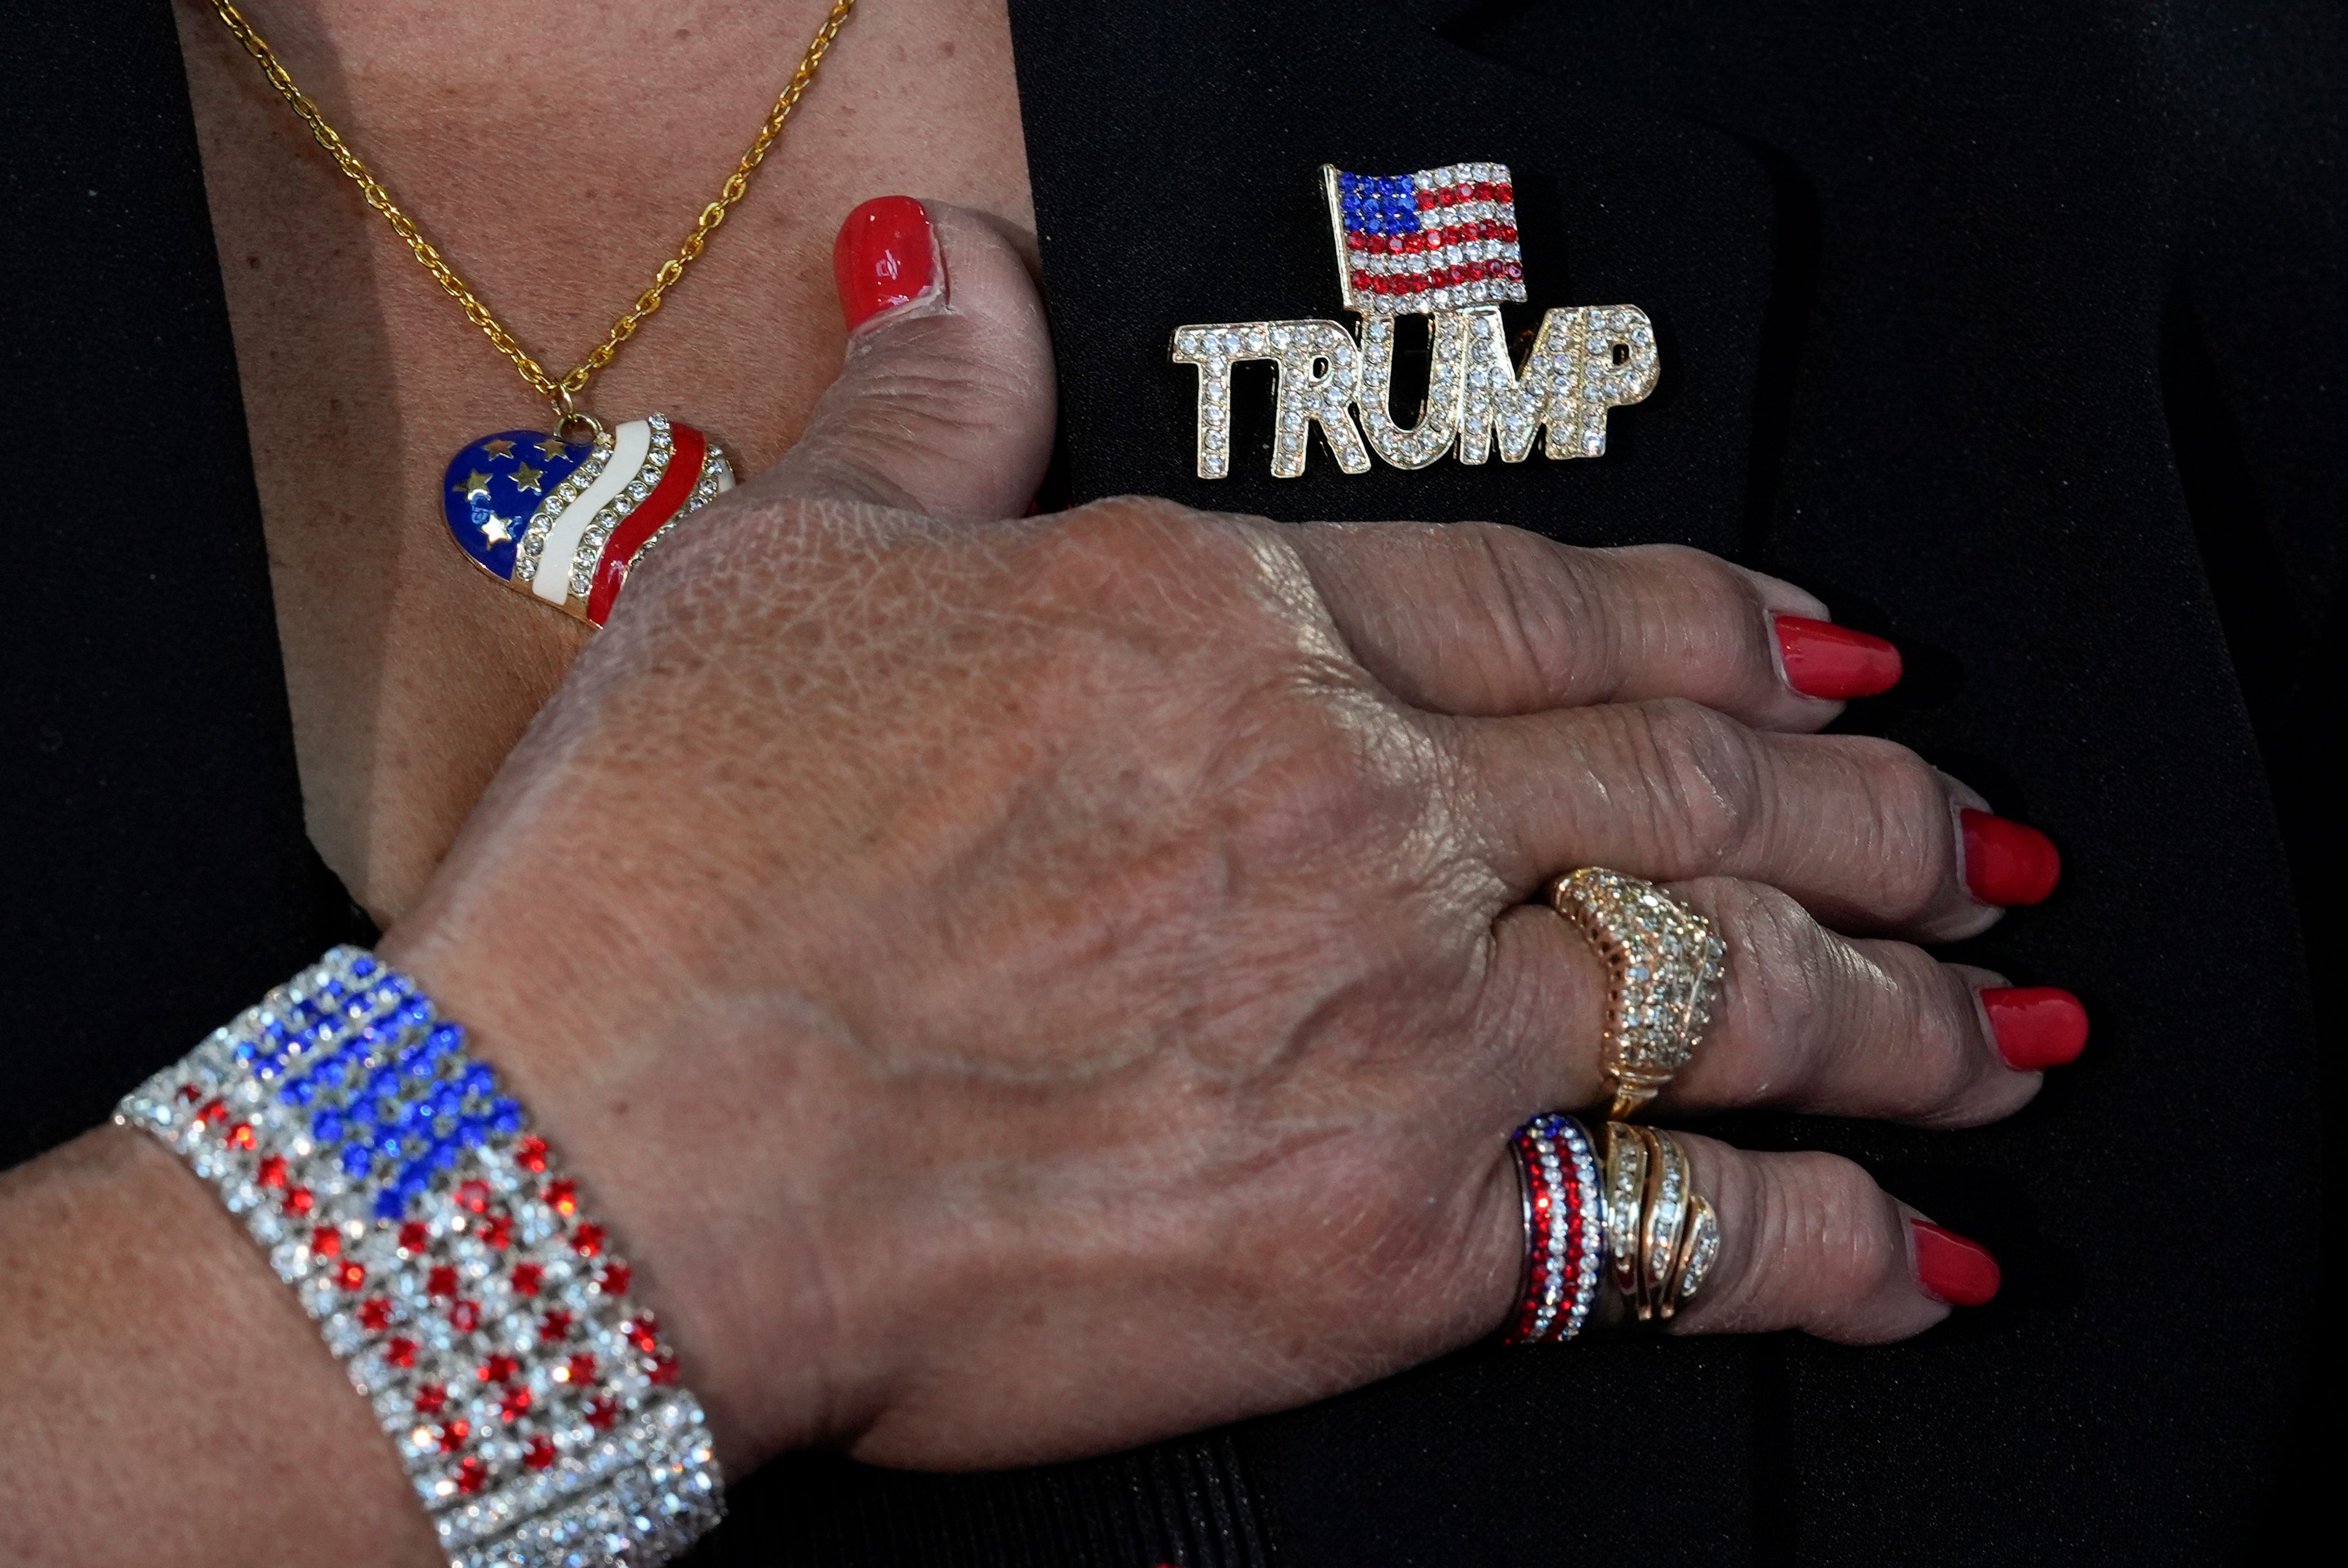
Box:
[1549,866,1728,1120]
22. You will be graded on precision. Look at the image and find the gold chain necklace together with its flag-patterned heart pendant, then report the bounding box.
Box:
[212,0,857,627]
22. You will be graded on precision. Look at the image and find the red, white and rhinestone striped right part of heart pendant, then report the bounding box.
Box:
[531,416,735,627]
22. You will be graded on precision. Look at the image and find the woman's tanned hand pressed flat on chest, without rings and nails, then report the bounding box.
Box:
[385,212,2038,1467]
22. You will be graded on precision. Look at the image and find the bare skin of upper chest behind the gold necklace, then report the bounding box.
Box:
[179,0,1035,920]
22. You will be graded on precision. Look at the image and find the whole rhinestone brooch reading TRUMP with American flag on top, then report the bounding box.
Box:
[1174,164,1658,479]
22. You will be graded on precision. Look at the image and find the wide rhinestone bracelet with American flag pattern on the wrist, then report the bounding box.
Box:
[115,948,723,1568]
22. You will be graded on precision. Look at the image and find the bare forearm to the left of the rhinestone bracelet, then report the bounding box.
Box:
[0,1127,448,1568]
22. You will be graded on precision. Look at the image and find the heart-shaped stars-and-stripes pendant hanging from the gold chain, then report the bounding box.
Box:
[441,413,733,627]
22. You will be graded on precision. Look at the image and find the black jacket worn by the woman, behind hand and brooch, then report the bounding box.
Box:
[0,0,2348,1568]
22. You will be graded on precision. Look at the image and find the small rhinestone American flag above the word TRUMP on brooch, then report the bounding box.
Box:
[1322,164,1524,317]
